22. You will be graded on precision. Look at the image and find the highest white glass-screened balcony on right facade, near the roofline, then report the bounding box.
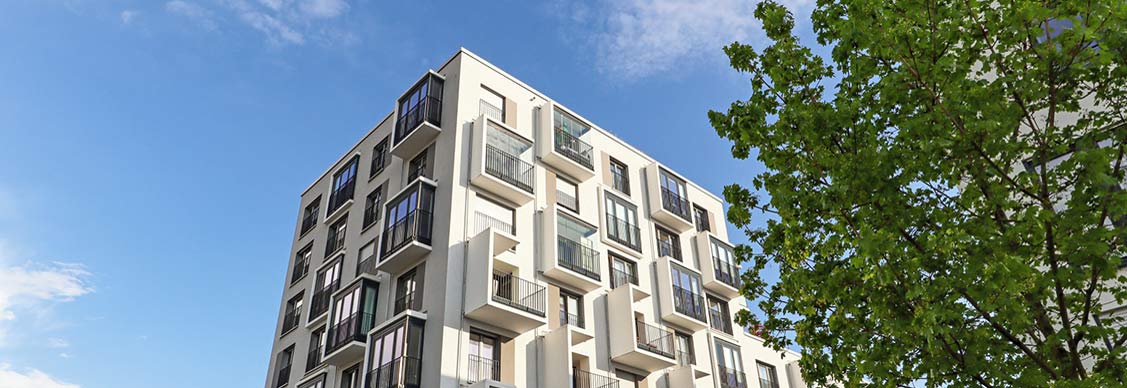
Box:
[536,104,595,182]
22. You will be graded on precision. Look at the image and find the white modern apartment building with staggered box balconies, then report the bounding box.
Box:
[266,50,805,388]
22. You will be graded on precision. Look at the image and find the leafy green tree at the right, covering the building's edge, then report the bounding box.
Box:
[709,0,1127,387]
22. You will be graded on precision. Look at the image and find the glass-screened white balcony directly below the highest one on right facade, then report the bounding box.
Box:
[540,205,603,292]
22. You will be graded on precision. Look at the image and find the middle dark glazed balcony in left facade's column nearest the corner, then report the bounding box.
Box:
[376,177,436,273]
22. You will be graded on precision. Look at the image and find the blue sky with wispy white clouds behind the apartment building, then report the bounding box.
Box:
[0,0,805,388]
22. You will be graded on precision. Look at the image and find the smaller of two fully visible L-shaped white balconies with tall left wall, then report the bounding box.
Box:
[606,286,676,372]
